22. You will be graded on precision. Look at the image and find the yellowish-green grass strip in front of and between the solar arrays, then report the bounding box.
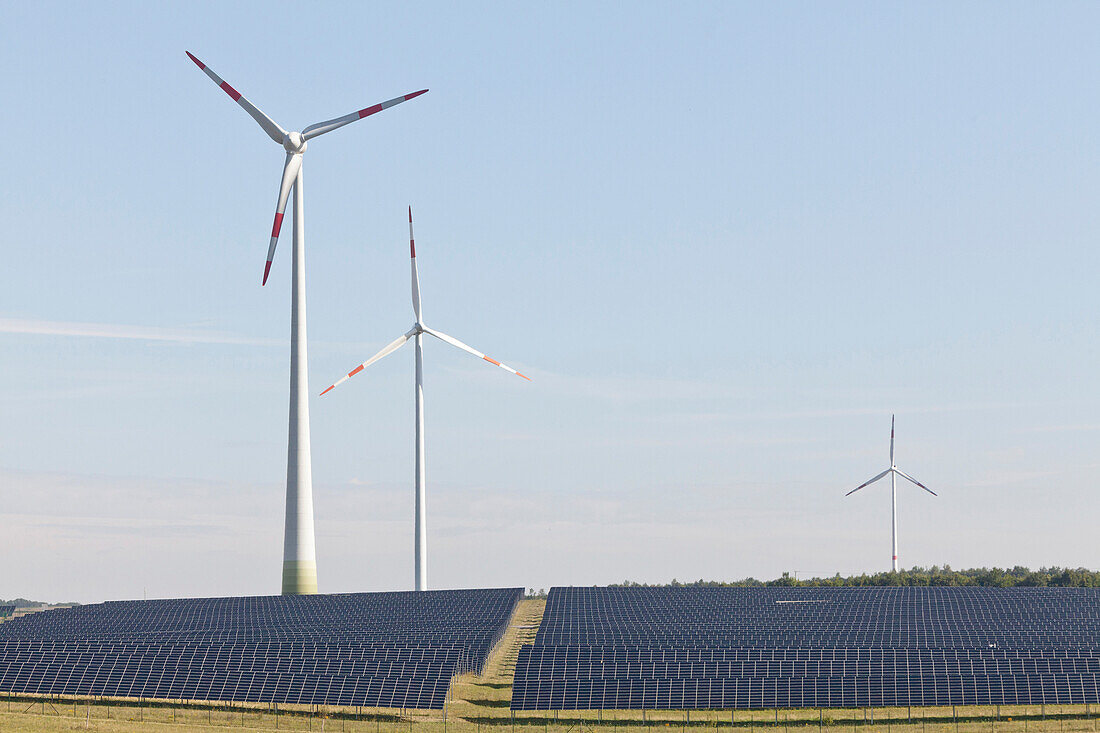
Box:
[0,601,1100,733]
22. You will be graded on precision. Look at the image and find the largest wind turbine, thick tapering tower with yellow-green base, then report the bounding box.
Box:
[187,51,428,594]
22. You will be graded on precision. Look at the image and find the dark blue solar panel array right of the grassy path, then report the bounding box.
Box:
[512,588,1100,710]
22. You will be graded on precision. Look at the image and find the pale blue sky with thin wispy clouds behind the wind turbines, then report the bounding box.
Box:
[0,0,1100,601]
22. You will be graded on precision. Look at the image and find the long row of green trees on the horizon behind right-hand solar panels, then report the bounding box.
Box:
[612,565,1100,588]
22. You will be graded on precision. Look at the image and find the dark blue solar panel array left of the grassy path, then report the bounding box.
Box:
[0,588,523,709]
